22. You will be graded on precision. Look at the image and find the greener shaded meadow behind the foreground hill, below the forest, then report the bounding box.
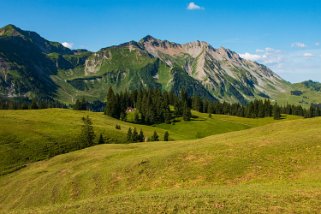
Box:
[0,109,295,174]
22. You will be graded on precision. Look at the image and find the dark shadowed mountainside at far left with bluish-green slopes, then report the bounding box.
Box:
[0,25,91,98]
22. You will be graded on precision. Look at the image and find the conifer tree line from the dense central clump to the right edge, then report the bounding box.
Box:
[105,88,321,124]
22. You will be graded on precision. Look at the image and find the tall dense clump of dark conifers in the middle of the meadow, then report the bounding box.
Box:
[105,88,192,125]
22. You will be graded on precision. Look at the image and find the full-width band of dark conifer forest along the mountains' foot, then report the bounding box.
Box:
[0,88,321,125]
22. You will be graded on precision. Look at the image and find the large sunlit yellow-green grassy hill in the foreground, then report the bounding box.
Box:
[0,118,321,213]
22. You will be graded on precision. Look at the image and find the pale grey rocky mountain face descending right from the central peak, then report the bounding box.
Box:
[140,36,288,103]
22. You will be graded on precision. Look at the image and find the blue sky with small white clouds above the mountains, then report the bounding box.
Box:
[0,0,321,82]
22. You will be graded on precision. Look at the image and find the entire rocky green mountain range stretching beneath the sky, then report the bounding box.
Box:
[0,25,321,106]
